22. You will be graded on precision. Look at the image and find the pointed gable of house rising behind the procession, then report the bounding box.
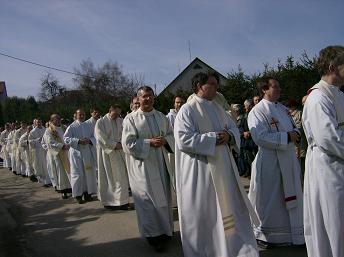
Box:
[160,57,227,95]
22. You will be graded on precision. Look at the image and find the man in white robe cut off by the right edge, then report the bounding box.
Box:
[302,46,344,257]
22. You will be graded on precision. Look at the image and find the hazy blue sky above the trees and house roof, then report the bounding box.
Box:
[0,0,344,97]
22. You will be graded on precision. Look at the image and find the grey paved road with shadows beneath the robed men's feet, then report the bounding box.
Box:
[0,169,307,257]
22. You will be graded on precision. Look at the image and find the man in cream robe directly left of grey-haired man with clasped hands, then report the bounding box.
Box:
[95,106,129,210]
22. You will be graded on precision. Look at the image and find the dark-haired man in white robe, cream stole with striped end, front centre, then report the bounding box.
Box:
[174,72,259,257]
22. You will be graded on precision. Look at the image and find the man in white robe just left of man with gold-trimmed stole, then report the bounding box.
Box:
[28,118,51,186]
